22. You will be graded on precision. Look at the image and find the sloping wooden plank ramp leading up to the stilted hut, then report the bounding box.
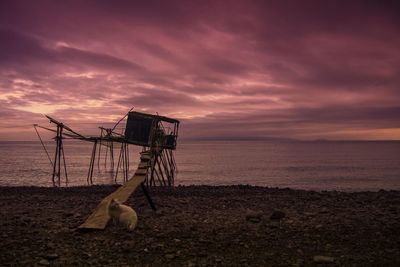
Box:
[78,155,149,230]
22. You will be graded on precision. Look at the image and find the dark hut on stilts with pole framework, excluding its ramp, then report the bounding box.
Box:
[34,109,179,186]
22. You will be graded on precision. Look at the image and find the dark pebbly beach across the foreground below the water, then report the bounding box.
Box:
[0,186,400,266]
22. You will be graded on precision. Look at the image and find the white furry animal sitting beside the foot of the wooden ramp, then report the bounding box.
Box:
[108,199,137,231]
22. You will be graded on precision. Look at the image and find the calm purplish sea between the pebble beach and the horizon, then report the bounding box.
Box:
[0,141,400,191]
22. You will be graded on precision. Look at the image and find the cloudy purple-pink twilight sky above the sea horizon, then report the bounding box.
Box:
[0,0,400,140]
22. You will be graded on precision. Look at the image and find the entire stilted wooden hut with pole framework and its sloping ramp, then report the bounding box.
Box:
[34,110,179,229]
